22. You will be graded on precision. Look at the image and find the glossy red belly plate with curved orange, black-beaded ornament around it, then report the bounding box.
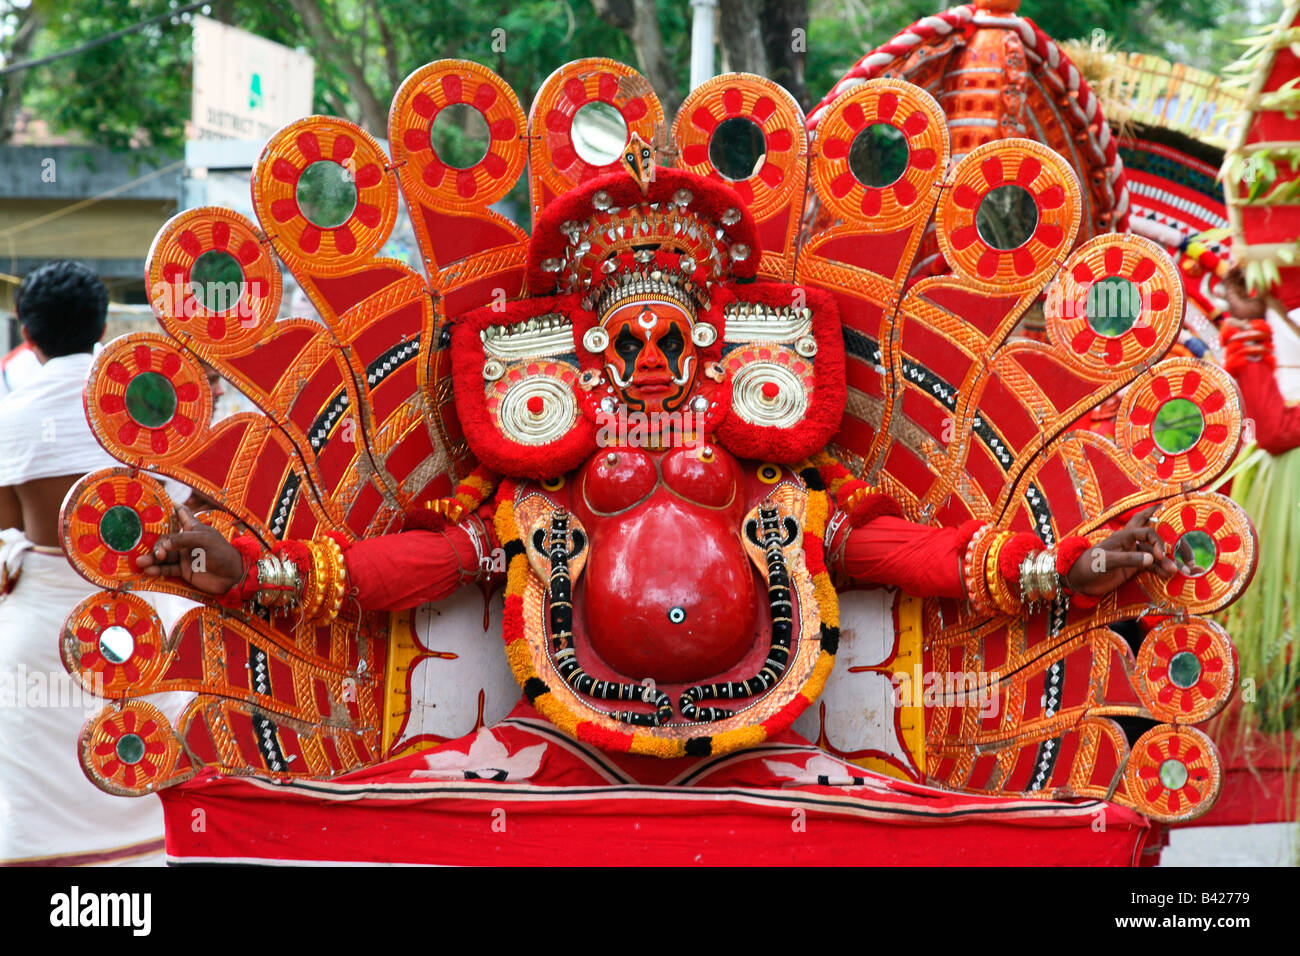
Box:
[497,465,839,757]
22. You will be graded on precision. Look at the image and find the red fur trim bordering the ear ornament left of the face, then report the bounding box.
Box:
[451,295,595,480]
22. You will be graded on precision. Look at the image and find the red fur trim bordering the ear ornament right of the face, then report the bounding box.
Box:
[714,282,846,464]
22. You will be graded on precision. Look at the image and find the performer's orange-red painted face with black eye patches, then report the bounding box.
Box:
[605,302,699,414]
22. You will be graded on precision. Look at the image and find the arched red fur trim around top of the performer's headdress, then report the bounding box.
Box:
[528,166,762,295]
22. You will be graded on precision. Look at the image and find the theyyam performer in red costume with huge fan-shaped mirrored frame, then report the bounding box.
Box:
[62,48,1255,860]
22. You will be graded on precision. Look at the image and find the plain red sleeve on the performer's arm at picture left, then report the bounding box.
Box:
[343,525,480,611]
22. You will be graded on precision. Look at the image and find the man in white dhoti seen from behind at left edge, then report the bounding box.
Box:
[0,263,163,865]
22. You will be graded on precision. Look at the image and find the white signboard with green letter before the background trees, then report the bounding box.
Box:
[189,17,316,139]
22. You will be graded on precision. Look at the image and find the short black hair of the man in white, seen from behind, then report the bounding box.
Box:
[14,259,108,359]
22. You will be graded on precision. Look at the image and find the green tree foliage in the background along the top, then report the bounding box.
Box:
[0,0,1281,150]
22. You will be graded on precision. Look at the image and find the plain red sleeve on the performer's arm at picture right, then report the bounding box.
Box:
[839,515,980,598]
